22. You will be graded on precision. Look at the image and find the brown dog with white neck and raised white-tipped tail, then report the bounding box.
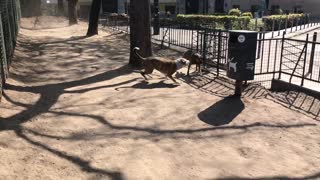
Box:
[133,47,190,83]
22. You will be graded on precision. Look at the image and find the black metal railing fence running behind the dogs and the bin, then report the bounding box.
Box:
[104,13,320,91]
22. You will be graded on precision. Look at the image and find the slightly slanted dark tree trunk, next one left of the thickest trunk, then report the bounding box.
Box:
[87,0,102,36]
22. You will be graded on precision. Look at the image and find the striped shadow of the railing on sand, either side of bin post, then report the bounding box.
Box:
[176,70,320,121]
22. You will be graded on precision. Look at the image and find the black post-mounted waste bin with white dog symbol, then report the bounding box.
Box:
[227,30,258,96]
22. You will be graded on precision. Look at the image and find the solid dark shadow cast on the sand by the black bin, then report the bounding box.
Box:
[198,96,245,126]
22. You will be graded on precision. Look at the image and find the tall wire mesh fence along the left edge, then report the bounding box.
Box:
[0,0,21,98]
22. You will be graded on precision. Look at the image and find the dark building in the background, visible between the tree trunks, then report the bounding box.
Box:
[40,0,320,17]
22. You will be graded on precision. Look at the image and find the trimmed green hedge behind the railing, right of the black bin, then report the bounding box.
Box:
[263,14,309,31]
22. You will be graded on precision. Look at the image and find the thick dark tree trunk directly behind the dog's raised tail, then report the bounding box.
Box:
[129,0,152,67]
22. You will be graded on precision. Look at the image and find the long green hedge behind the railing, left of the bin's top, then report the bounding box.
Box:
[175,14,251,29]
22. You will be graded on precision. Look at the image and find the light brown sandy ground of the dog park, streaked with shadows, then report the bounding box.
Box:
[0,16,320,180]
